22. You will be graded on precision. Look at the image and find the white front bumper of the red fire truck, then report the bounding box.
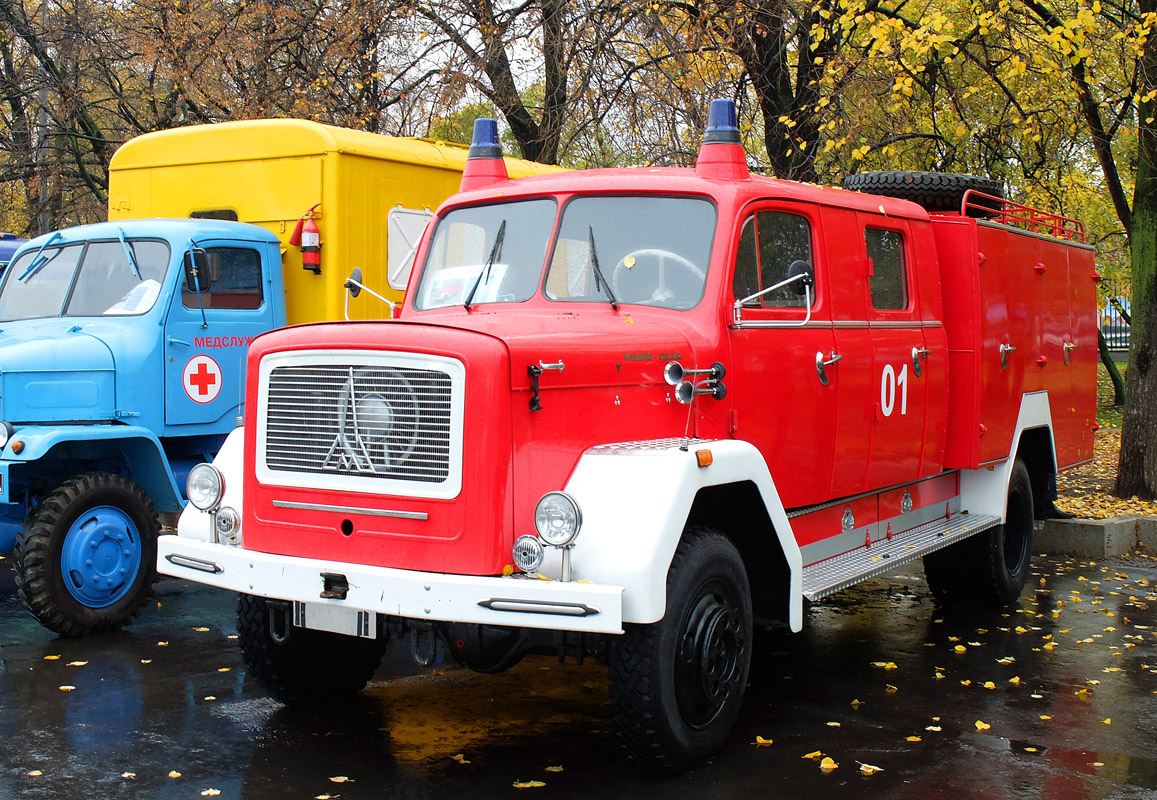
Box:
[156,535,622,633]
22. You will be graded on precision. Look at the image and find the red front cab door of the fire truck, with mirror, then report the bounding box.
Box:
[725,201,839,508]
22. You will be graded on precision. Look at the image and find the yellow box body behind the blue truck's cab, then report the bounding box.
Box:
[109,119,559,324]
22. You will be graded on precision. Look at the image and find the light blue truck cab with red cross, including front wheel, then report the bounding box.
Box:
[0,219,286,636]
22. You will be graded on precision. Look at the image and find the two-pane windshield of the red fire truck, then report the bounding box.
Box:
[414,195,716,310]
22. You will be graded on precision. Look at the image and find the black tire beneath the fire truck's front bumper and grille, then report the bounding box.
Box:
[237,594,390,705]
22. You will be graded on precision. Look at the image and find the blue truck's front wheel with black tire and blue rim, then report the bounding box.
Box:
[13,472,161,637]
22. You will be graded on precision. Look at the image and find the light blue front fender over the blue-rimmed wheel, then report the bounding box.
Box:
[0,425,185,512]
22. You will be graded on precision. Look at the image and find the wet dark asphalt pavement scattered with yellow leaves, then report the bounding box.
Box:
[0,557,1157,800]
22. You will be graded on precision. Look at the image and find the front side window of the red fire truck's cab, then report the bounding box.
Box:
[732,211,816,308]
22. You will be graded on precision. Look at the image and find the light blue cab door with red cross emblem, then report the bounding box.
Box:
[164,242,274,427]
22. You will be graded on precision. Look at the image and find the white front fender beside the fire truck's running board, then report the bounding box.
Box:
[543,440,803,631]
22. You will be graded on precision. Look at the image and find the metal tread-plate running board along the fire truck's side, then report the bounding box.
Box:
[803,514,1001,600]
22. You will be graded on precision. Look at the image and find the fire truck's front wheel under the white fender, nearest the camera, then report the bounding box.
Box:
[610,528,752,772]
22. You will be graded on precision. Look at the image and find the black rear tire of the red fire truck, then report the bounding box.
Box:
[924,458,1033,605]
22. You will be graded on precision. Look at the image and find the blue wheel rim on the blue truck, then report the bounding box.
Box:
[60,506,141,608]
